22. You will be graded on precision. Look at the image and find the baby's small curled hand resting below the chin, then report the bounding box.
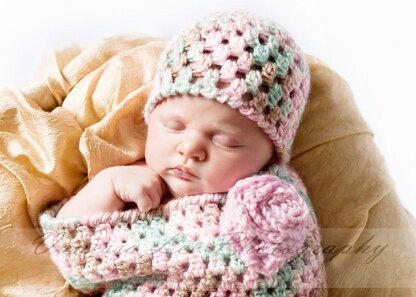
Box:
[109,161,167,212]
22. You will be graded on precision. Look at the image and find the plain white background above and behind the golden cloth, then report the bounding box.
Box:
[0,0,416,216]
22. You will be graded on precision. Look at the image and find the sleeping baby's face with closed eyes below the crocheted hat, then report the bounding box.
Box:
[145,96,273,197]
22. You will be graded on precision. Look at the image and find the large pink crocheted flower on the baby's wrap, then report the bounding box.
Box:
[220,175,309,277]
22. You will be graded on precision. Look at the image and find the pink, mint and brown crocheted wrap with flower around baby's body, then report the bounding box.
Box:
[39,165,326,296]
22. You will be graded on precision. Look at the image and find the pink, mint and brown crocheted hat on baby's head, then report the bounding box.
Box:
[144,12,310,163]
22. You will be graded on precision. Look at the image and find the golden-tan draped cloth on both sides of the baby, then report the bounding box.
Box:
[0,36,416,296]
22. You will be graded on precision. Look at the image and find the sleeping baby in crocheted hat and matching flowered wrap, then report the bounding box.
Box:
[40,12,326,296]
